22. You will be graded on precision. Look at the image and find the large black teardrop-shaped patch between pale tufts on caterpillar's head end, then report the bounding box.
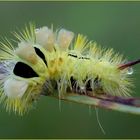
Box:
[13,62,38,78]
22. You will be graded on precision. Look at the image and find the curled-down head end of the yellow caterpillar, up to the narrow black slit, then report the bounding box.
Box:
[0,42,48,114]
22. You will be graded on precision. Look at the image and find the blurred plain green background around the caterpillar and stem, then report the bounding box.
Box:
[0,2,140,138]
